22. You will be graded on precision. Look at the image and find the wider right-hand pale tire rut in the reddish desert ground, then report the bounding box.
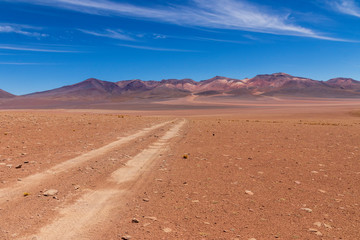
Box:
[19,120,186,240]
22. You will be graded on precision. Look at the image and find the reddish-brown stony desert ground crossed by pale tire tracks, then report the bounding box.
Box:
[0,103,360,240]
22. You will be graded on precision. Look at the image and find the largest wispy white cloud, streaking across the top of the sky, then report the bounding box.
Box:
[7,0,339,41]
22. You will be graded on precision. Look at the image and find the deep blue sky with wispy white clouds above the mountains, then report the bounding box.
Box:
[0,0,360,94]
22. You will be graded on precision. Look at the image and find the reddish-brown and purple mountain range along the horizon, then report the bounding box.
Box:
[0,73,360,100]
